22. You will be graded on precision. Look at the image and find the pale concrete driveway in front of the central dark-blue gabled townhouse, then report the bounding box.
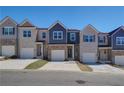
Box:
[40,61,81,72]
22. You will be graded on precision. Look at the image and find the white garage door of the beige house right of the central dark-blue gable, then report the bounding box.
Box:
[82,53,97,63]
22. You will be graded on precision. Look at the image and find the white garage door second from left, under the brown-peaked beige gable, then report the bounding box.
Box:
[20,48,34,58]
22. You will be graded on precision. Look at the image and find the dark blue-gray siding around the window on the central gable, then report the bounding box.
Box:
[49,23,66,44]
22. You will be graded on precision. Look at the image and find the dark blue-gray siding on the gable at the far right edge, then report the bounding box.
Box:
[112,29,124,50]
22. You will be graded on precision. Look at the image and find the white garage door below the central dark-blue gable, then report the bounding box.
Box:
[51,50,65,61]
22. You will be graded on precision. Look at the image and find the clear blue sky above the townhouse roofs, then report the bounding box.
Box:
[0,6,124,32]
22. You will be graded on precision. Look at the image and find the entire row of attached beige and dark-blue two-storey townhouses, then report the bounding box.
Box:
[0,16,124,65]
